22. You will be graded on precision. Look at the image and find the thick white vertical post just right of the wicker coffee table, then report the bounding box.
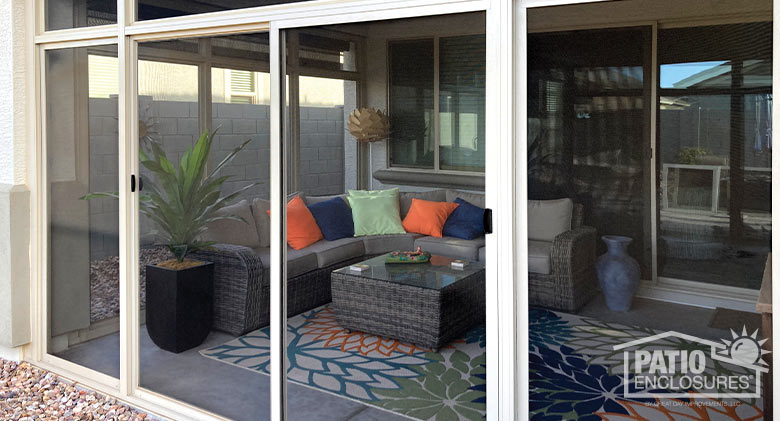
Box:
[485,0,516,420]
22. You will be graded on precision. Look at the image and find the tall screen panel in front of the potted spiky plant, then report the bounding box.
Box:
[136,33,271,420]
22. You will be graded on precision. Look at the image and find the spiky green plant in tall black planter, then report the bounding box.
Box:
[84,132,257,353]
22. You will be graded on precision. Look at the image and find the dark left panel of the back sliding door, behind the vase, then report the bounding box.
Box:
[528,28,652,279]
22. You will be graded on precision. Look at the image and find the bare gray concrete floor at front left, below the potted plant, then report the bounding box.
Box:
[58,328,406,421]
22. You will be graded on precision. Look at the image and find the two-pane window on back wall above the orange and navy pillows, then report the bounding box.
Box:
[389,35,486,172]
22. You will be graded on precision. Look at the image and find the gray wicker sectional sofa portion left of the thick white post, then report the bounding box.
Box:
[193,190,485,335]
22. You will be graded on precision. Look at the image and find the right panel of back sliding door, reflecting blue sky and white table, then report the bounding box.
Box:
[657,22,773,289]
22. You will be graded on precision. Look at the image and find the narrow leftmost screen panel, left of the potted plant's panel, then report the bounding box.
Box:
[44,45,120,378]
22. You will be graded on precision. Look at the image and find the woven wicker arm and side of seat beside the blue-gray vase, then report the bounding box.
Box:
[528,204,598,312]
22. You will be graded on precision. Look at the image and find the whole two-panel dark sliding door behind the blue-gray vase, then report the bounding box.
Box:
[528,9,772,302]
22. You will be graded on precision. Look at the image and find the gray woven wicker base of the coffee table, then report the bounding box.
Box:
[331,270,485,351]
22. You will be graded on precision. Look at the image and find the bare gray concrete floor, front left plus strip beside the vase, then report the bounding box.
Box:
[54,295,731,421]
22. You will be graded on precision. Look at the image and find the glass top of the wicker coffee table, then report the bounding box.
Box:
[335,253,485,289]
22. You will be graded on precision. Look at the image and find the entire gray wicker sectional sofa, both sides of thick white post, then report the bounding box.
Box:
[193,190,597,335]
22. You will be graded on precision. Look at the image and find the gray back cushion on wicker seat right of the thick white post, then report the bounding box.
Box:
[528,199,574,241]
